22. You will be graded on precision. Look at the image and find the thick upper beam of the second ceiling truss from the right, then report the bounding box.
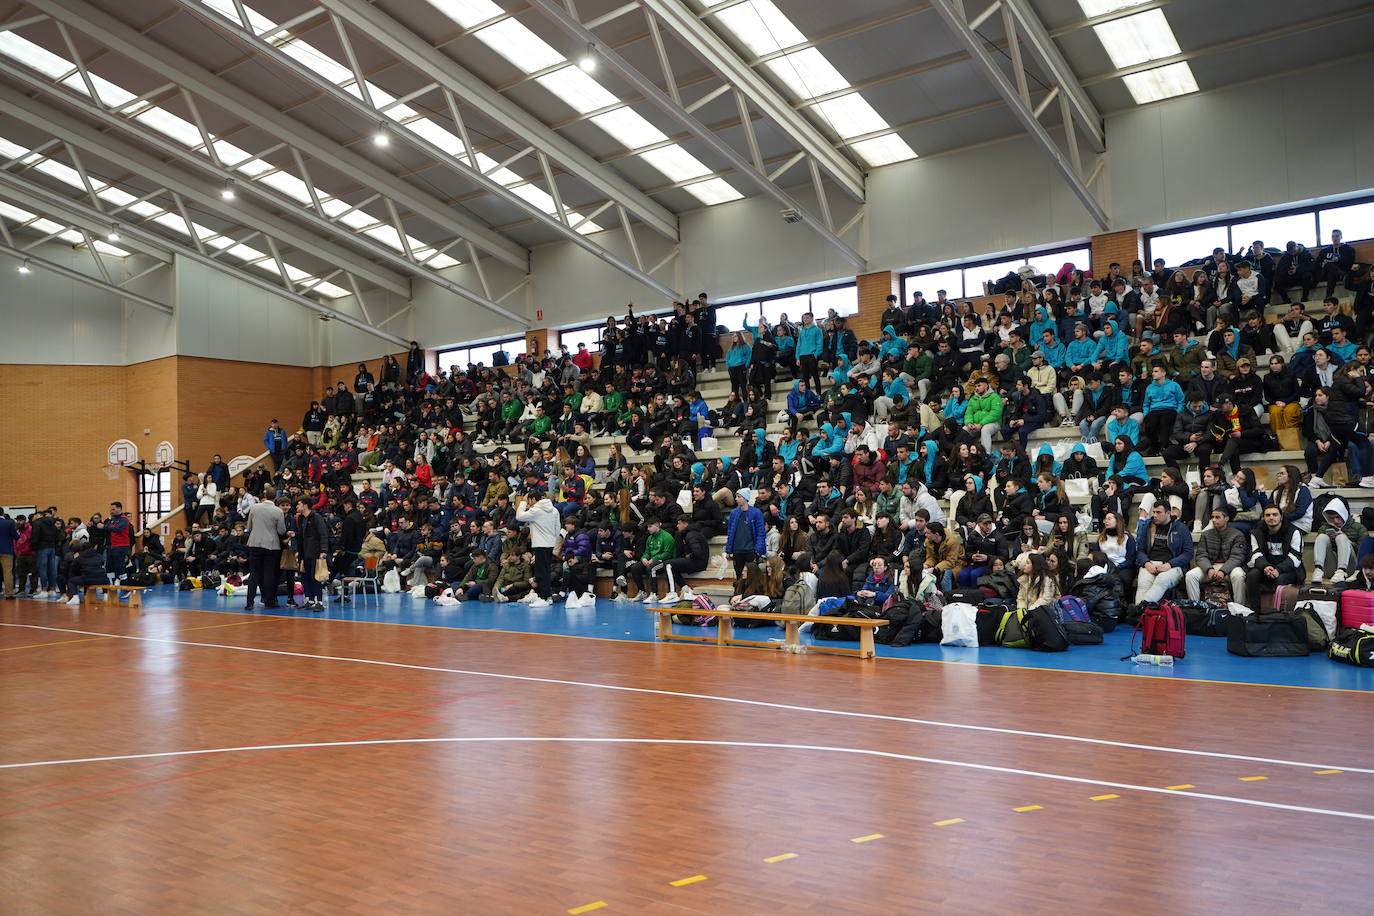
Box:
[632,0,864,202]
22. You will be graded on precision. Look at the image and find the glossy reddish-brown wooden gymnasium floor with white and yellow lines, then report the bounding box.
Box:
[0,602,1374,913]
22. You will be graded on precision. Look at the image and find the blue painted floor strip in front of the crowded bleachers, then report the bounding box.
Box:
[120,586,1374,691]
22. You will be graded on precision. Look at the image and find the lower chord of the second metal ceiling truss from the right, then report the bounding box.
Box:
[530,0,867,269]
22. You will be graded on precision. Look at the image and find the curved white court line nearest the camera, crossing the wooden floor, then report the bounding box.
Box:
[0,736,1374,821]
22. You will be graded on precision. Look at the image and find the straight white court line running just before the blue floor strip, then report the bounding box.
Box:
[0,618,1374,775]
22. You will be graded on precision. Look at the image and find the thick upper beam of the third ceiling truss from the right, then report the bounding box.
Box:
[311,0,677,240]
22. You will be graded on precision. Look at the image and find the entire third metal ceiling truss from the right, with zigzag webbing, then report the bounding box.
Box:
[171,0,682,299]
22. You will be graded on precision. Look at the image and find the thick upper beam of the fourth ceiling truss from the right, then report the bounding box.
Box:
[29,0,529,271]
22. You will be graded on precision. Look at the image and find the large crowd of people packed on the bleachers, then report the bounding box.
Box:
[16,235,1374,626]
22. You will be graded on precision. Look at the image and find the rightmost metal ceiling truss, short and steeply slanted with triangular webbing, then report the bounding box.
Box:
[932,0,1110,229]
